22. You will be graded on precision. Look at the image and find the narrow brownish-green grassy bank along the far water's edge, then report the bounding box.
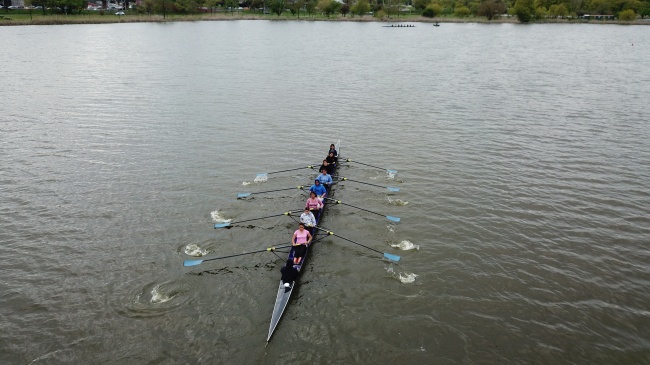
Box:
[0,12,650,26]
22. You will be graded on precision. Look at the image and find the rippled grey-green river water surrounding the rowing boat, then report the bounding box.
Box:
[0,21,650,364]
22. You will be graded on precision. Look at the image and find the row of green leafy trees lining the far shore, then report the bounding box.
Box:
[19,0,650,22]
